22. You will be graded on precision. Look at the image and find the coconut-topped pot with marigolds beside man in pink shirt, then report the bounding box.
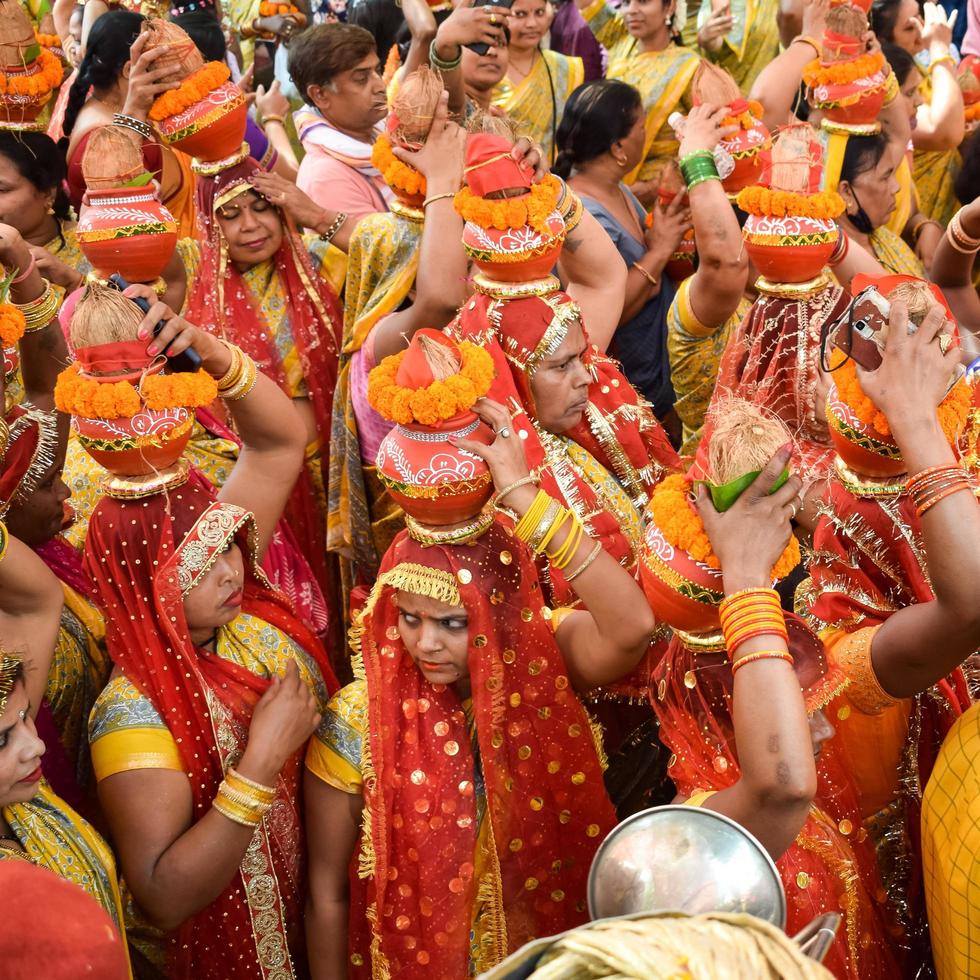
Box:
[371,66,443,217]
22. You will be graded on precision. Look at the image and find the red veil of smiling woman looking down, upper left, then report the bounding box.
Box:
[187,157,344,586]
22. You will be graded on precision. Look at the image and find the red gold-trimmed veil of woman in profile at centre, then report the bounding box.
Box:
[448,288,680,604]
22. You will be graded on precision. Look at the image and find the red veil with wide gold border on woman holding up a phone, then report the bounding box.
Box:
[85,483,336,980]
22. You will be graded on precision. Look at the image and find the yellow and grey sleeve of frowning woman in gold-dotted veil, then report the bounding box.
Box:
[306,680,367,795]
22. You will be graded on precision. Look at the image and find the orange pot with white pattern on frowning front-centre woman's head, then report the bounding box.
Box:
[377,412,494,527]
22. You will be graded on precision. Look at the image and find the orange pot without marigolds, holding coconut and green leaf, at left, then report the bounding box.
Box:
[76,187,177,282]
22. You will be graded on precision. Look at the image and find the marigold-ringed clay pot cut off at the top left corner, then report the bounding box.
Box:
[0,0,64,129]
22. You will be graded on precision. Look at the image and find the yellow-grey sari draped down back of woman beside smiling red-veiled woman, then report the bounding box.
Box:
[327,204,422,587]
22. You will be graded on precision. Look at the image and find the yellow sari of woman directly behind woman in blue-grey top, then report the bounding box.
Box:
[582,0,701,184]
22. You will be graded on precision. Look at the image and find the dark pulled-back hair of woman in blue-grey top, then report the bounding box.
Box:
[551,78,643,178]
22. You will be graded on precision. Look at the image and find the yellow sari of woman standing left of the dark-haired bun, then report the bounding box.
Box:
[491,50,585,163]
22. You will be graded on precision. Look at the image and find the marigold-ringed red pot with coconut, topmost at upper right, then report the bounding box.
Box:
[803,4,896,134]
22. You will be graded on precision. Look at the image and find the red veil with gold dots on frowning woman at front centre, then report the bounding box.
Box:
[351,523,615,980]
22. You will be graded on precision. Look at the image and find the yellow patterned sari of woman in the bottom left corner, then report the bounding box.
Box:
[0,779,132,976]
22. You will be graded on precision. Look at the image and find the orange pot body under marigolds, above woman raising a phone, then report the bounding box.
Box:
[72,407,194,477]
